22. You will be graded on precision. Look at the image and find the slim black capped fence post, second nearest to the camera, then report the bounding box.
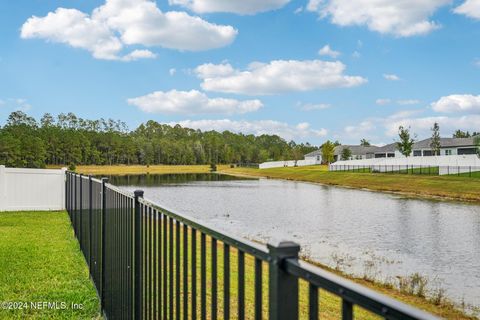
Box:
[133,190,143,320]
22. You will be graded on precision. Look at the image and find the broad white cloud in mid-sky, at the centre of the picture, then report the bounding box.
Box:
[195,60,367,95]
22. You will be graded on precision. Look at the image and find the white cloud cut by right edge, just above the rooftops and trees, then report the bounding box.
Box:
[431,94,480,113]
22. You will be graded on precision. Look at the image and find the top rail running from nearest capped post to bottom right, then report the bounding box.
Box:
[285,259,438,320]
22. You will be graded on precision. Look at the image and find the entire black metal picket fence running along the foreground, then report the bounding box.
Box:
[65,172,436,320]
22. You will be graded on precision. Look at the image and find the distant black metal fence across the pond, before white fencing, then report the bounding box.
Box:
[329,164,480,178]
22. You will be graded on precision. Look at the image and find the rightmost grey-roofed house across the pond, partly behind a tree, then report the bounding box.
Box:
[412,136,480,157]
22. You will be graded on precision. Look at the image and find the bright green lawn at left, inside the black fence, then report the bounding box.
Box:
[0,212,100,319]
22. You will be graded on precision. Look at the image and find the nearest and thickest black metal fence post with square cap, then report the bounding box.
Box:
[268,241,300,320]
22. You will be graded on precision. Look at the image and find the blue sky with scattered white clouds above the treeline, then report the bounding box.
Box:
[0,0,480,144]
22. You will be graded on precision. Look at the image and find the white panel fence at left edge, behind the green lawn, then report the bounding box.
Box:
[0,166,66,211]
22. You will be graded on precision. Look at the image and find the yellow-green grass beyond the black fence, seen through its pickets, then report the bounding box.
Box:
[146,222,474,320]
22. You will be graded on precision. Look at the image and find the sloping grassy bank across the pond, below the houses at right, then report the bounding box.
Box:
[221,166,480,202]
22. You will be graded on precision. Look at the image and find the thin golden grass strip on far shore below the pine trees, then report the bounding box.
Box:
[49,165,229,175]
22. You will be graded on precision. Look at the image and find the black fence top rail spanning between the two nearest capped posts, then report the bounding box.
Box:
[139,198,270,261]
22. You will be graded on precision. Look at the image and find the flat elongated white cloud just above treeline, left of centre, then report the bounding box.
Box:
[127,90,263,115]
